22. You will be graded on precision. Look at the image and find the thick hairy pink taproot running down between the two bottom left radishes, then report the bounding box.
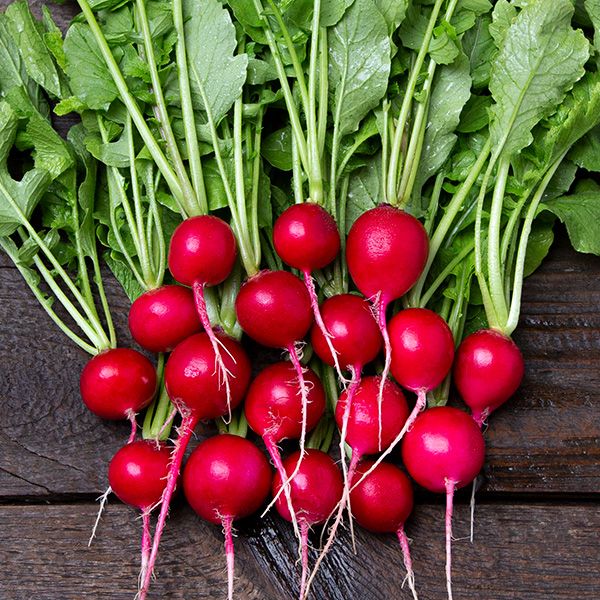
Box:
[139,415,198,600]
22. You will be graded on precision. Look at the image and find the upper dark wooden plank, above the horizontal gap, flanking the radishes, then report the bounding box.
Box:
[0,234,600,498]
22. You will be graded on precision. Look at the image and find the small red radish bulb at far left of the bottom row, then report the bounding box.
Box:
[108,440,171,510]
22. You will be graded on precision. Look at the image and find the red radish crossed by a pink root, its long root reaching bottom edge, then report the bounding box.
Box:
[307,377,409,593]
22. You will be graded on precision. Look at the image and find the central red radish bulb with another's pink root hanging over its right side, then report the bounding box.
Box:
[244,362,325,443]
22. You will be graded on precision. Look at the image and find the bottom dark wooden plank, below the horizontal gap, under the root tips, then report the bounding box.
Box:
[0,504,600,600]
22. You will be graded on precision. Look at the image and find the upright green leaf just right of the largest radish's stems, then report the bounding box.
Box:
[417,54,471,191]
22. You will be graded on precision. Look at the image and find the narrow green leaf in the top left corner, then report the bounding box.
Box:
[5,1,62,97]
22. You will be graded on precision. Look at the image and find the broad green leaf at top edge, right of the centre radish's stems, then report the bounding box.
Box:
[329,0,391,136]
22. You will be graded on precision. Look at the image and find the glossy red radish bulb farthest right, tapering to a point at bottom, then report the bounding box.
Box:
[454,329,525,422]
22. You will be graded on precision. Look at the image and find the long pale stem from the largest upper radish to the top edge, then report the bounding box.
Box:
[386,0,444,202]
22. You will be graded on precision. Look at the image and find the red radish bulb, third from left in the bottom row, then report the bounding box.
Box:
[272,448,344,525]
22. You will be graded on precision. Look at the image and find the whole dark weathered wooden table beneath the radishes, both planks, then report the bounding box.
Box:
[0,0,600,600]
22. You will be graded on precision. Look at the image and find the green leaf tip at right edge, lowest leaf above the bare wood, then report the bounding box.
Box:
[540,185,600,255]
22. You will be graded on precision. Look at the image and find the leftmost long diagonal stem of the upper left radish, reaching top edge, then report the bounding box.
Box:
[77,0,186,215]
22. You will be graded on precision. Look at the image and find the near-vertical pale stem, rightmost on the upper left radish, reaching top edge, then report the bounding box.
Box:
[173,0,208,214]
